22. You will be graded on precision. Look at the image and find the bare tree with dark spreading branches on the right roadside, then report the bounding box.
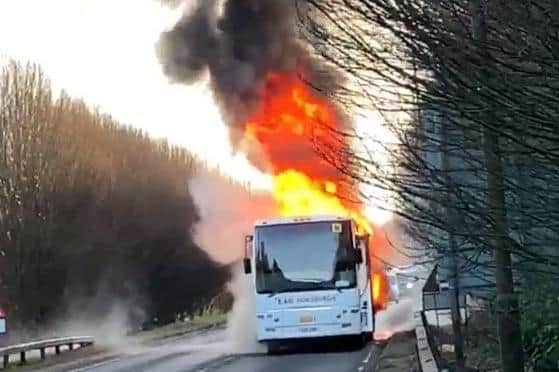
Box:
[299,0,559,371]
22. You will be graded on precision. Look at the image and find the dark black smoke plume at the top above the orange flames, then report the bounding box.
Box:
[157,0,339,144]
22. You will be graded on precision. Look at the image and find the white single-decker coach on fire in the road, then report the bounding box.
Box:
[244,216,374,352]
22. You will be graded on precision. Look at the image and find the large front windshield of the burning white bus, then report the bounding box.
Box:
[255,221,356,293]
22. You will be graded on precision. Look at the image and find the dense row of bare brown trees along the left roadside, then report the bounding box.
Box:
[0,63,228,334]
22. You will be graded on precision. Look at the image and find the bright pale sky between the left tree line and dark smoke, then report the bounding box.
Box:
[0,0,271,189]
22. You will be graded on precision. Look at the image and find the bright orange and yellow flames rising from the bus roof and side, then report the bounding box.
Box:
[244,73,387,308]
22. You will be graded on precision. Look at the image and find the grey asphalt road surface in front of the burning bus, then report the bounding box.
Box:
[43,330,380,372]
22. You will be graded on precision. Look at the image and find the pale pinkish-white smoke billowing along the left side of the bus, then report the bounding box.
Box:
[189,170,274,353]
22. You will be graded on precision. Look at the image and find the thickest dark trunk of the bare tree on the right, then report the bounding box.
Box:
[470,0,524,372]
